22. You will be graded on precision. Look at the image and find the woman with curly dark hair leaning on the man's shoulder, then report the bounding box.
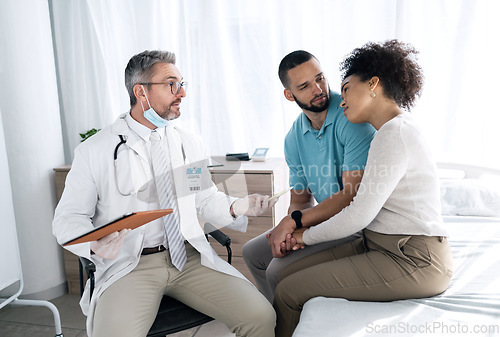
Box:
[274,40,452,337]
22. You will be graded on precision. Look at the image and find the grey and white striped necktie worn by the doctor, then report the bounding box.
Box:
[150,130,187,271]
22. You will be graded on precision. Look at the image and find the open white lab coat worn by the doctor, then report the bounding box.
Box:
[53,114,248,336]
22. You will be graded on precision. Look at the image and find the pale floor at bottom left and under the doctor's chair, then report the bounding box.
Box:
[0,295,234,337]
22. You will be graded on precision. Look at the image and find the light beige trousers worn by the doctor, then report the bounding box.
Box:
[93,244,276,337]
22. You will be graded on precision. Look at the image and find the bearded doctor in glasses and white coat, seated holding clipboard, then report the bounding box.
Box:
[53,51,276,337]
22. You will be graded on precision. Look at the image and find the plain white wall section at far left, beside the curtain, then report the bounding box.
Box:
[0,0,65,299]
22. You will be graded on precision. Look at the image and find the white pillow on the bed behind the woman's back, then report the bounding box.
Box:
[441,179,500,216]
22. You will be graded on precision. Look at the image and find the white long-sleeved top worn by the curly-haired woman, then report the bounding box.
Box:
[303,113,446,245]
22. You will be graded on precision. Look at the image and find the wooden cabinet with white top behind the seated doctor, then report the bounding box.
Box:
[54,156,290,294]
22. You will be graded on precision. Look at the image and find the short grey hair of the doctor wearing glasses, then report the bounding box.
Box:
[125,50,175,107]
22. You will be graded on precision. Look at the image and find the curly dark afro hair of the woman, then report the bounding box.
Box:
[340,40,424,110]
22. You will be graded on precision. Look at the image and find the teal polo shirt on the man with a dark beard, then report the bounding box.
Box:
[285,92,375,202]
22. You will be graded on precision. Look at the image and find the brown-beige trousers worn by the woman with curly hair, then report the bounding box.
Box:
[274,229,453,337]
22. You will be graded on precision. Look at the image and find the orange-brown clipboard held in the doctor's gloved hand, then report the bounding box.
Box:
[63,208,173,246]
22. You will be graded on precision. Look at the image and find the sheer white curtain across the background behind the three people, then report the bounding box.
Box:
[49,0,500,167]
